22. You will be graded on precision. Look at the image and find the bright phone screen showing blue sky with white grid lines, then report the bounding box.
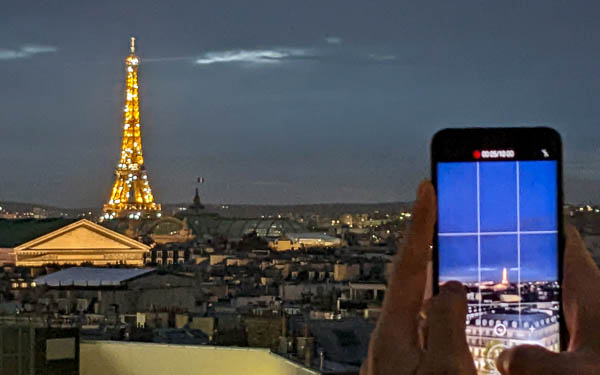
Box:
[437,161,560,374]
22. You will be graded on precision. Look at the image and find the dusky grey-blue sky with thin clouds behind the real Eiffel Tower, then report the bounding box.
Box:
[0,0,600,207]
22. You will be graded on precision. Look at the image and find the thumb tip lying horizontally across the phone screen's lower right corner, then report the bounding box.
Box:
[496,345,580,375]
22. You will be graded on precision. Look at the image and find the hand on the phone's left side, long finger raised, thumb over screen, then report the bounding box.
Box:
[360,181,476,375]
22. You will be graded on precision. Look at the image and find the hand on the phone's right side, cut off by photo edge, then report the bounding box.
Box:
[497,225,600,375]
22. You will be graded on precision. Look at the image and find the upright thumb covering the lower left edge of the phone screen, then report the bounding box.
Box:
[427,281,468,359]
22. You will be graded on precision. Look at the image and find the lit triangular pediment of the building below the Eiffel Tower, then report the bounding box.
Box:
[15,219,149,251]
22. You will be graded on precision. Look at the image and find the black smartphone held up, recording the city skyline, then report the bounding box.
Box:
[431,127,566,374]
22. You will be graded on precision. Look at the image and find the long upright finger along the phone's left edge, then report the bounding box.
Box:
[383,181,436,322]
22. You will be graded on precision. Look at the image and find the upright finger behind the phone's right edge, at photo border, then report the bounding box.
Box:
[563,225,600,350]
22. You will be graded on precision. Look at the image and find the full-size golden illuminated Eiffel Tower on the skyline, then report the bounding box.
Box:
[103,38,160,219]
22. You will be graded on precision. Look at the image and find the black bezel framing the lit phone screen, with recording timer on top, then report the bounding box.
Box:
[431,127,569,350]
